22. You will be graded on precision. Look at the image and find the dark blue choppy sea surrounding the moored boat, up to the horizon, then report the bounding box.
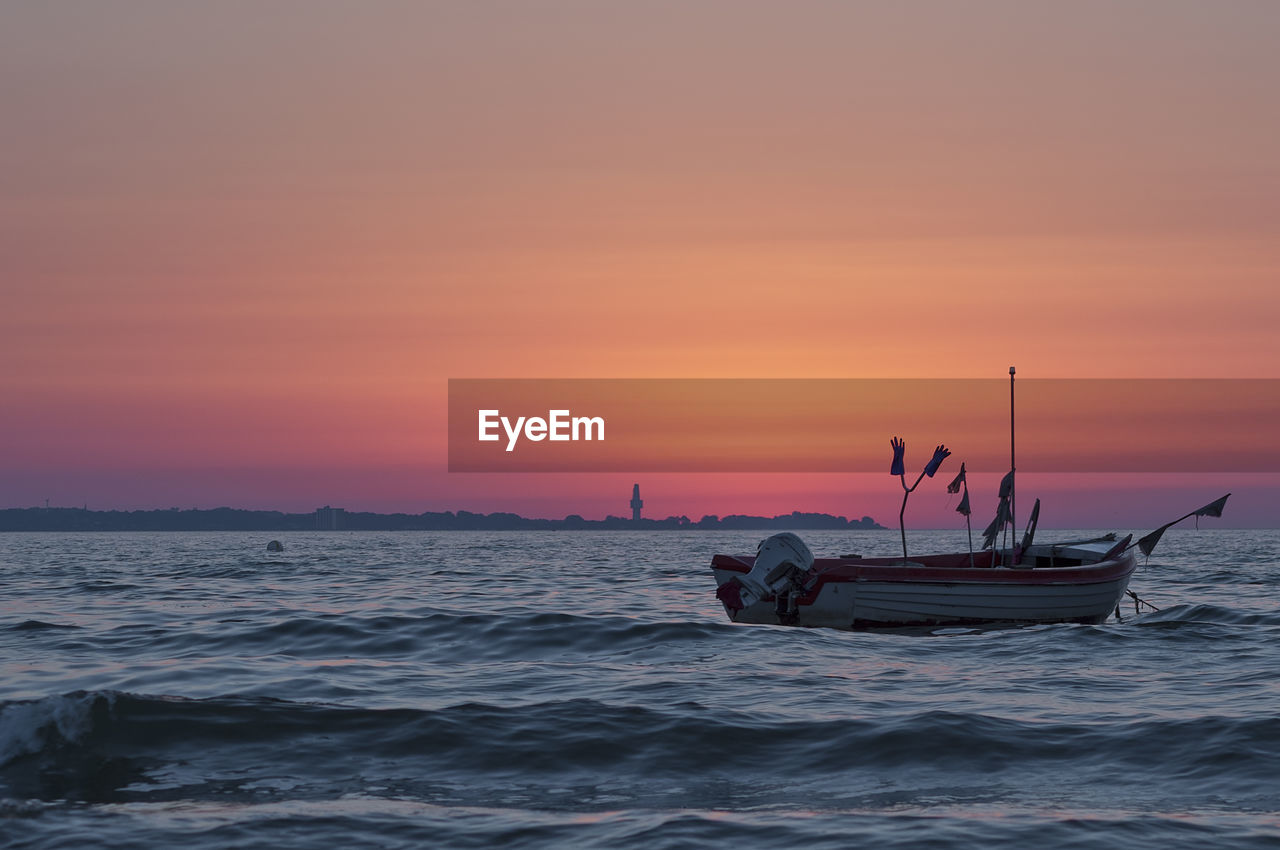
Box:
[0,529,1280,850]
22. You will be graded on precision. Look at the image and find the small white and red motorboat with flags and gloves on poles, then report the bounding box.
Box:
[710,367,1230,629]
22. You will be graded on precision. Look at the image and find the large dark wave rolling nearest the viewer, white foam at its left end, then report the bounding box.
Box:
[0,691,1280,781]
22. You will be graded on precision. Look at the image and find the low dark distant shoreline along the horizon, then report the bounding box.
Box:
[0,506,884,533]
